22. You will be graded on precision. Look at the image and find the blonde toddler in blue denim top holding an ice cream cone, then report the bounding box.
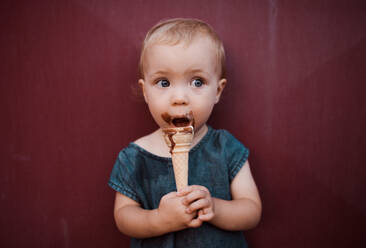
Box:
[109,19,261,248]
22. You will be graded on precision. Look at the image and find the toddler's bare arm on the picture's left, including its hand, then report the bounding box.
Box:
[114,192,202,238]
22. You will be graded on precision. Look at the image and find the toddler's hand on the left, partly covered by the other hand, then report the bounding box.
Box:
[158,192,202,231]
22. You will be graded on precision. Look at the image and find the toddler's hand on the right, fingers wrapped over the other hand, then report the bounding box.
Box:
[177,185,215,221]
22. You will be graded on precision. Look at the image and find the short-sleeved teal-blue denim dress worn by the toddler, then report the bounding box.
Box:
[108,127,249,248]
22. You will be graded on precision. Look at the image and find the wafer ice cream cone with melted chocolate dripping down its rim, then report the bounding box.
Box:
[163,126,193,191]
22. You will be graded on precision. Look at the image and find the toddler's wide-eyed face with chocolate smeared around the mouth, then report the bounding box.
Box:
[139,36,226,132]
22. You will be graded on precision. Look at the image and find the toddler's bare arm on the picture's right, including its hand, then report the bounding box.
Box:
[178,162,262,231]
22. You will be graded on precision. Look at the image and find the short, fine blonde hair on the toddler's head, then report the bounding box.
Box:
[139,18,225,78]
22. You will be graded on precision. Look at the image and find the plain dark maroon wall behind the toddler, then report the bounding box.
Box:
[0,0,366,248]
